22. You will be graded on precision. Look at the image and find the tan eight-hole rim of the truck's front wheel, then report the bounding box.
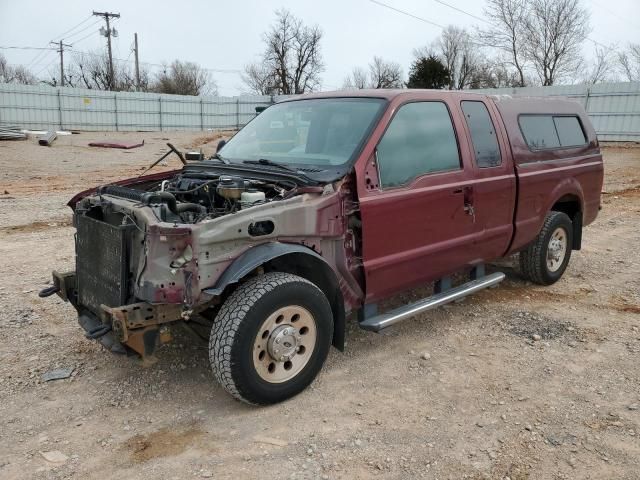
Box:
[253,305,318,383]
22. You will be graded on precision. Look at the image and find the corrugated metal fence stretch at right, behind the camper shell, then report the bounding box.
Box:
[476,82,640,142]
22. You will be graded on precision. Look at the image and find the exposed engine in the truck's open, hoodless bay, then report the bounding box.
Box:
[98,172,290,223]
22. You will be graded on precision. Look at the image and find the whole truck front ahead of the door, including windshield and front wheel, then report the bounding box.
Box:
[41,98,386,404]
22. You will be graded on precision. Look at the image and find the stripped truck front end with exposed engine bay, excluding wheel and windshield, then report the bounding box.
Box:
[42,156,362,363]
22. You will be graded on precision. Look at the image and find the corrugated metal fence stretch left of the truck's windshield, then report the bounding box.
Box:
[0,84,275,131]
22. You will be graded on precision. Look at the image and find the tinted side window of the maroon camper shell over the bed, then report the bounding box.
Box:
[518,114,587,150]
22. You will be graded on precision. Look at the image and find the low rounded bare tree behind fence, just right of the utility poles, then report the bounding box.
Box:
[152,60,218,96]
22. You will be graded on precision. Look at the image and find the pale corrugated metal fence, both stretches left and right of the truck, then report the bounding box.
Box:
[0,82,640,141]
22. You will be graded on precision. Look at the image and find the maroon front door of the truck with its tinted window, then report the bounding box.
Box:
[356,94,478,302]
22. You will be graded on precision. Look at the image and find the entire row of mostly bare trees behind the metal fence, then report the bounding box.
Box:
[0,0,640,95]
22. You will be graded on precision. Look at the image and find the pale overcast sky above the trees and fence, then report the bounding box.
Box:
[0,0,640,95]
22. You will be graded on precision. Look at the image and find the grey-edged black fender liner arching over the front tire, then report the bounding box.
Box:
[203,242,346,351]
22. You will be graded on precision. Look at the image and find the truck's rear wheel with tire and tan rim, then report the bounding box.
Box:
[520,212,573,285]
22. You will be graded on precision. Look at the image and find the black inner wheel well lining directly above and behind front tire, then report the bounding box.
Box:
[263,252,345,351]
